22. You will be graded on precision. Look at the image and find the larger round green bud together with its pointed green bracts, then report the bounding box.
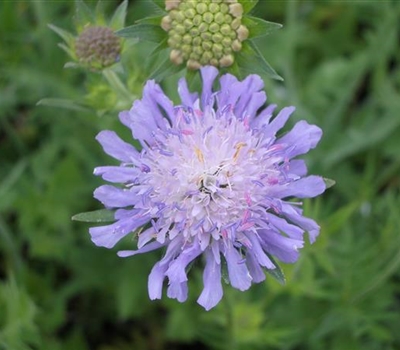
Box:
[116,0,281,79]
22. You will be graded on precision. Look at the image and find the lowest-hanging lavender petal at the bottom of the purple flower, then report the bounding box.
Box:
[197,249,223,311]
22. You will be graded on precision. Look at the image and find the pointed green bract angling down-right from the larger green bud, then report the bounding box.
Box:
[237,40,283,81]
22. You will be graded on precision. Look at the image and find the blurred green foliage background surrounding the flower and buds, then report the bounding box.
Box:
[0,0,400,350]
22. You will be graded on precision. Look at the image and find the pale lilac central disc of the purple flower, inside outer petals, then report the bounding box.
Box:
[144,108,280,242]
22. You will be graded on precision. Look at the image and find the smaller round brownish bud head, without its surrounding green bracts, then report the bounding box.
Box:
[75,26,121,69]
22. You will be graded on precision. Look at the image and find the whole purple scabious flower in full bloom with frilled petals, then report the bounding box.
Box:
[90,66,325,310]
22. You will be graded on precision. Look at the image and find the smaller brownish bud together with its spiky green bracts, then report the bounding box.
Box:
[49,0,128,71]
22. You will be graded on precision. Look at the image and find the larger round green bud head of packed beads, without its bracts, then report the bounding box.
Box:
[161,0,249,69]
